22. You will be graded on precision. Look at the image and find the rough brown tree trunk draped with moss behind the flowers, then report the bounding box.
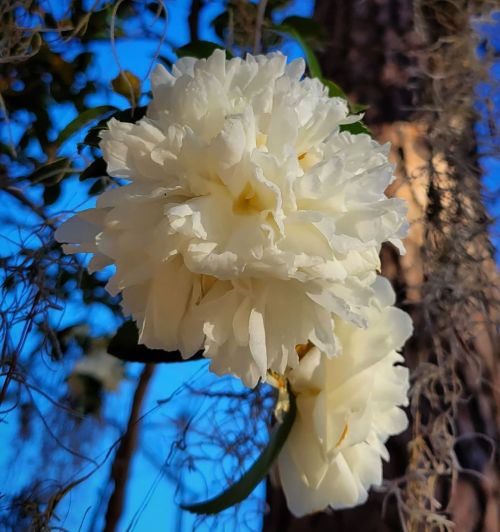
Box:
[264,0,500,532]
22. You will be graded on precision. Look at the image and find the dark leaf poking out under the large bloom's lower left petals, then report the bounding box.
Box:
[108,321,203,363]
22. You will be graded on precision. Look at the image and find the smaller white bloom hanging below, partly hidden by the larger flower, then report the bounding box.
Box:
[278,280,412,516]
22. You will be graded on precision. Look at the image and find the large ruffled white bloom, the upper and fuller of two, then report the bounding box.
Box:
[57,50,406,386]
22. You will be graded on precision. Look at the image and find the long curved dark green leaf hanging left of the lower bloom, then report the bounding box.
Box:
[180,388,297,515]
